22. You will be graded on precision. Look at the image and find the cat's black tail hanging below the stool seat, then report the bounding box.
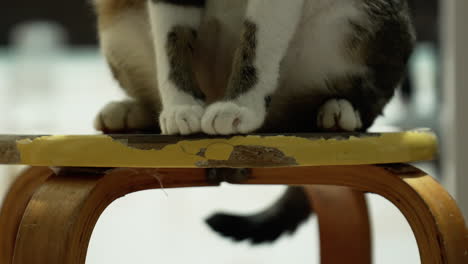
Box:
[206,187,312,244]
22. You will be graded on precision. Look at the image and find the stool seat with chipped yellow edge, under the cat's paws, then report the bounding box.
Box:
[0,131,437,168]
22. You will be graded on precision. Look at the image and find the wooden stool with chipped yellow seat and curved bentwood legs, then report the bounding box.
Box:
[0,131,468,264]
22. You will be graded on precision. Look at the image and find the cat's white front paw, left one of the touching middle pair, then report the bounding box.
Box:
[159,105,204,135]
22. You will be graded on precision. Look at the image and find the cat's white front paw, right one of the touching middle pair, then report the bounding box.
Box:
[202,102,266,135]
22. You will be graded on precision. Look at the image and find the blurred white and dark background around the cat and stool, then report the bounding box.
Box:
[0,0,468,264]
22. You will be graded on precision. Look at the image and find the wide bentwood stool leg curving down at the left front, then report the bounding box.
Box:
[10,169,209,264]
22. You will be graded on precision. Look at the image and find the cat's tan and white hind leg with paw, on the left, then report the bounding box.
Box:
[94,0,161,133]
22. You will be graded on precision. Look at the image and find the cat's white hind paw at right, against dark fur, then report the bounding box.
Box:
[317,99,362,131]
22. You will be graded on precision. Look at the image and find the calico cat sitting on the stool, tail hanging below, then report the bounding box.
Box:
[94,0,415,243]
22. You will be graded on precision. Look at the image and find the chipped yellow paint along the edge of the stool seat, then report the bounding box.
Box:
[17,131,437,168]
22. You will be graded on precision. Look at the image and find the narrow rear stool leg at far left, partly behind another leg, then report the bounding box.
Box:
[0,167,54,264]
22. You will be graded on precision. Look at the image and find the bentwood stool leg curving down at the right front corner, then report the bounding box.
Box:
[248,164,468,264]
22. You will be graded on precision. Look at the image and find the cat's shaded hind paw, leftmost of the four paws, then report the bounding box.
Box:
[94,100,157,133]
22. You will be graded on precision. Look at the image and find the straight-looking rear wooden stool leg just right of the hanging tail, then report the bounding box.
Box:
[306,185,372,264]
